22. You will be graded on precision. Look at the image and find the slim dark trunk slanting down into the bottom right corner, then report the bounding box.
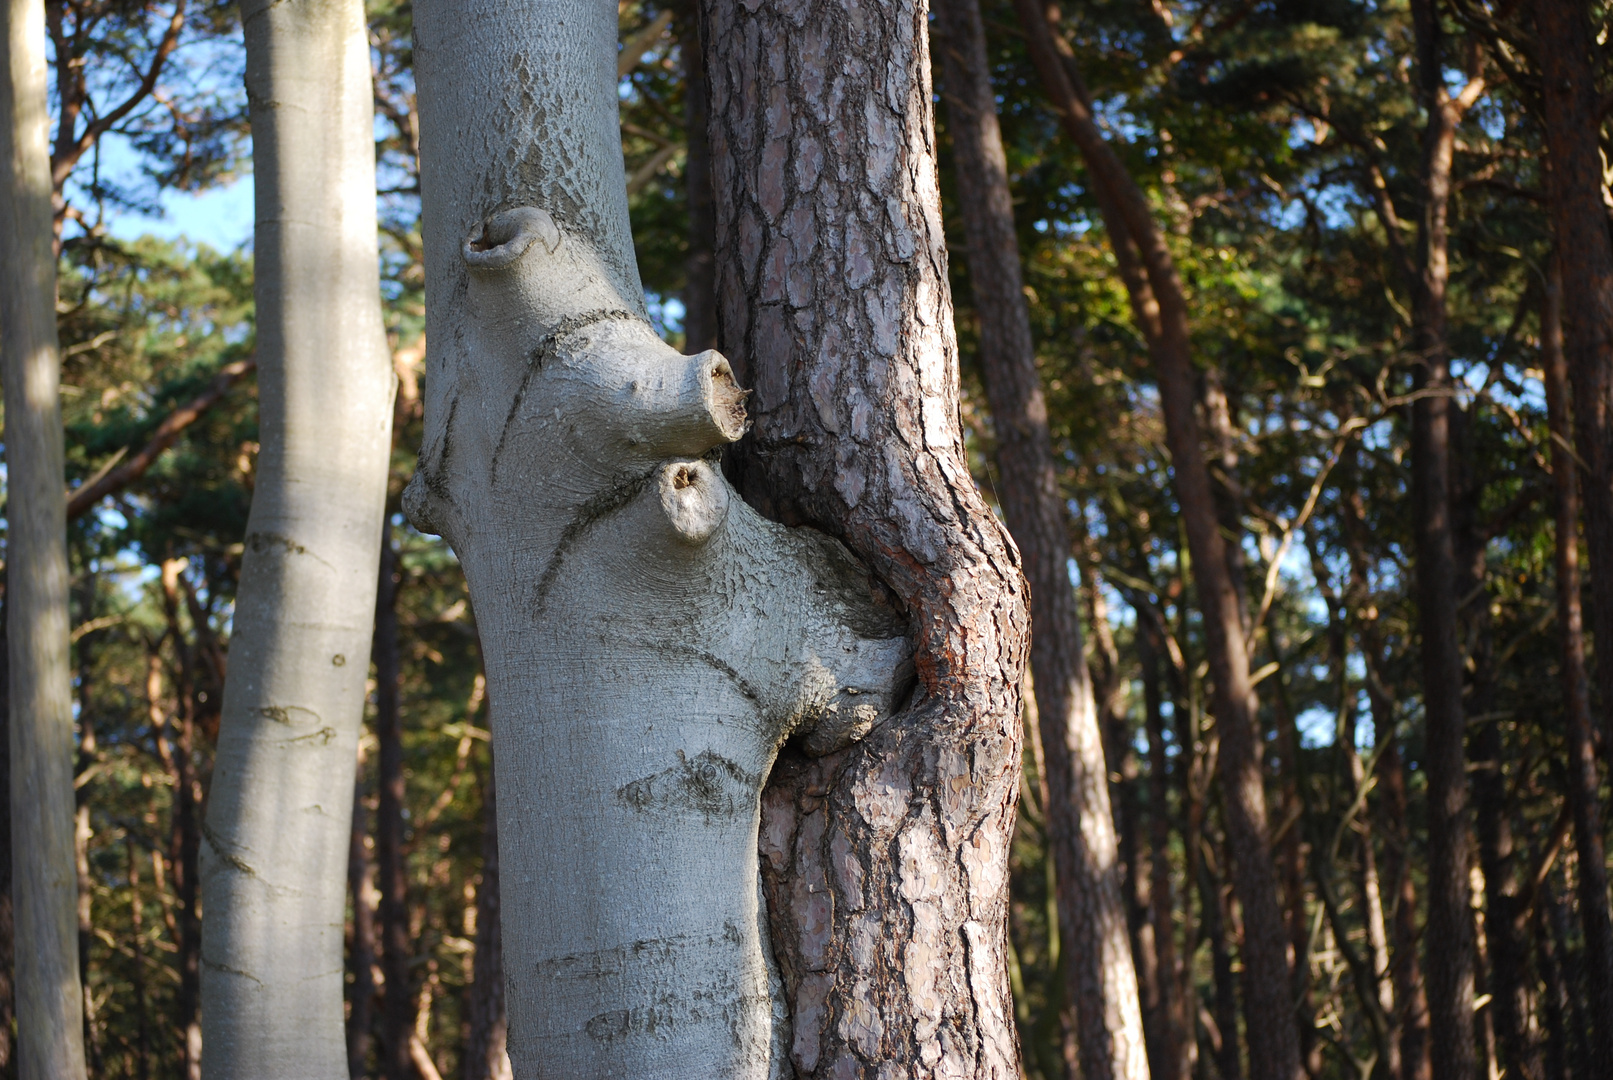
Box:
[1540,256,1613,1072]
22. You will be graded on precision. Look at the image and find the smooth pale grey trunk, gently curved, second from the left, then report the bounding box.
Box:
[202,0,394,1080]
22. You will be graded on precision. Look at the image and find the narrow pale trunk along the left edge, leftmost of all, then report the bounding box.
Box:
[0,0,84,1080]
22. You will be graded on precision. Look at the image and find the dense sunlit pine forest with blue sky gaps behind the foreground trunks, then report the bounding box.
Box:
[22,0,1613,1080]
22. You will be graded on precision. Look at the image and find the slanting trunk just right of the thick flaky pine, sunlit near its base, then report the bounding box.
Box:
[936,0,1148,1080]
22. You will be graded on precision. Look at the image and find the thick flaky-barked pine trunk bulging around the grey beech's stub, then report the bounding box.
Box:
[705,0,1026,1078]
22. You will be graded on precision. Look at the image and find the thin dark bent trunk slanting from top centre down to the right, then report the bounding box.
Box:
[1015,0,1302,1080]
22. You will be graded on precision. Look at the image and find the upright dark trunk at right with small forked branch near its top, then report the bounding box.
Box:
[1411,0,1476,1080]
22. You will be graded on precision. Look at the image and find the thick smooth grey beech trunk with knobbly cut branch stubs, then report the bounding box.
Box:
[403,0,927,1080]
